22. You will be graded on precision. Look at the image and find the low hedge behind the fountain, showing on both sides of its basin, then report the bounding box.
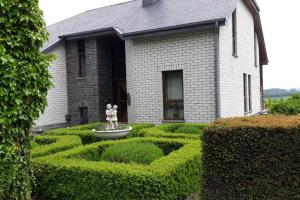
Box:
[46,122,154,145]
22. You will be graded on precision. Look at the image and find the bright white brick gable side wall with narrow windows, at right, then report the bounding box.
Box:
[219,0,260,118]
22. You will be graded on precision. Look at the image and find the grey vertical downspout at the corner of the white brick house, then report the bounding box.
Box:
[215,21,221,119]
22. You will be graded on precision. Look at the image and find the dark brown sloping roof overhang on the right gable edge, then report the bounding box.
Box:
[244,0,269,65]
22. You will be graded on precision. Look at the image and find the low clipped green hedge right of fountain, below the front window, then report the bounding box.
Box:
[138,124,207,139]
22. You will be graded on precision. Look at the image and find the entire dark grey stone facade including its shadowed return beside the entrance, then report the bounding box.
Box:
[66,38,112,125]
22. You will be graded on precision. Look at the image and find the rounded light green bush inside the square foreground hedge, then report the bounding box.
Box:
[101,143,164,164]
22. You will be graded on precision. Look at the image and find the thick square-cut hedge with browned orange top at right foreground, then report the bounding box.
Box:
[202,116,300,200]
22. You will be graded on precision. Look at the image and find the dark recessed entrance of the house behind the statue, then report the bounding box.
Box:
[97,35,128,122]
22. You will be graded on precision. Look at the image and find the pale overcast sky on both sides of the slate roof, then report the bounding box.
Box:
[40,0,300,89]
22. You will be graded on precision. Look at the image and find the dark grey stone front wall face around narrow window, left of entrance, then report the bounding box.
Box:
[66,38,100,124]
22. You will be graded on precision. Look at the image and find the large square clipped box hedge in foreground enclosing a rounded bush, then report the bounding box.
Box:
[34,138,201,200]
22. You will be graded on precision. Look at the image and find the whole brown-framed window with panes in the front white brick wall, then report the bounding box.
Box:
[163,71,184,120]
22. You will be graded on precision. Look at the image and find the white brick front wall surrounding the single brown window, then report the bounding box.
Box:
[126,31,215,123]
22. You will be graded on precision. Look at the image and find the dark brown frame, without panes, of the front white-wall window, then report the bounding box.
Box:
[162,70,184,121]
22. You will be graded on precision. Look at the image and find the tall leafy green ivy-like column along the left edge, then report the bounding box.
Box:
[0,0,52,199]
